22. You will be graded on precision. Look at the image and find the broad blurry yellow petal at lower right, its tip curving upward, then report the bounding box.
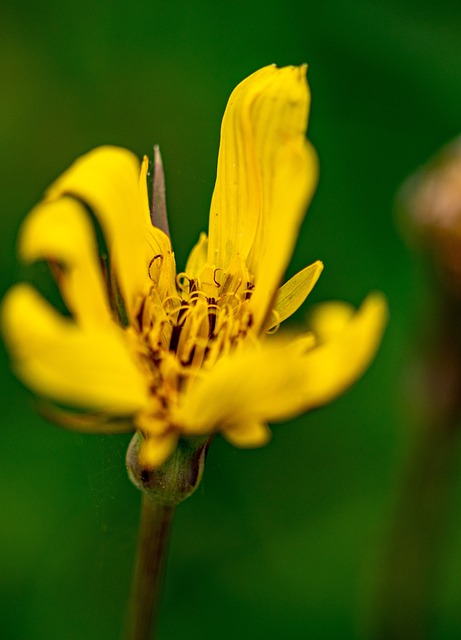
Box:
[174,294,387,435]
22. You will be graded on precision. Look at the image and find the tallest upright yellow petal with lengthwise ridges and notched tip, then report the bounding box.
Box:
[208,65,318,329]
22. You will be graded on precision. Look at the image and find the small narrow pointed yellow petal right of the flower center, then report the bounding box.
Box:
[266,260,323,331]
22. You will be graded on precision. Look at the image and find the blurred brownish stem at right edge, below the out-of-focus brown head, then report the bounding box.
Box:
[372,299,461,640]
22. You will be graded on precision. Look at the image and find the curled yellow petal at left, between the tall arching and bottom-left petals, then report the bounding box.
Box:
[19,198,111,327]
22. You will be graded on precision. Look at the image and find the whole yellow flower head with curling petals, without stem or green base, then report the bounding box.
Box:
[3,66,387,466]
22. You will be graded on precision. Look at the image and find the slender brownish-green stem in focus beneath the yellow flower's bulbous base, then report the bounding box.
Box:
[125,494,175,640]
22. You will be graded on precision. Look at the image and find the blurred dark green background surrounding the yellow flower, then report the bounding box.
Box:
[0,0,461,640]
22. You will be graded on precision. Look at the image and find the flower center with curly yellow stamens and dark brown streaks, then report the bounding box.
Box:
[131,265,253,416]
